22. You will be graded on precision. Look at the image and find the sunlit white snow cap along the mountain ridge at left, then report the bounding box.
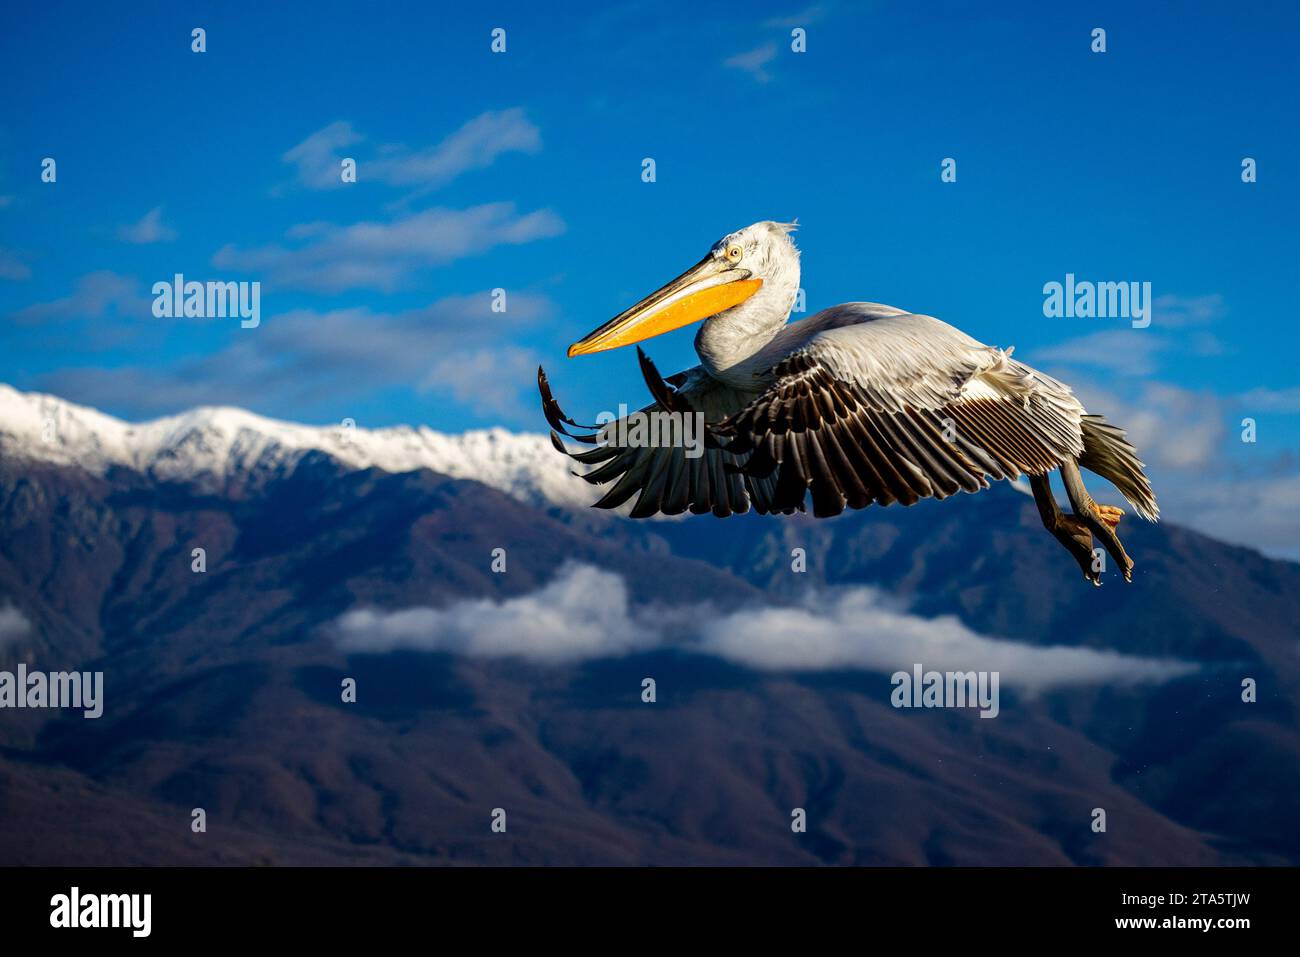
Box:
[0,384,592,507]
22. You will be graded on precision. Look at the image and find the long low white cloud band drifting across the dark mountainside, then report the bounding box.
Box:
[333,564,1197,693]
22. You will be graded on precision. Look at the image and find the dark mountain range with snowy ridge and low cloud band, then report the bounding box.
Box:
[0,386,1300,865]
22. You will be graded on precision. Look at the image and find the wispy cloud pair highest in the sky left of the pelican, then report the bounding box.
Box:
[282,107,542,190]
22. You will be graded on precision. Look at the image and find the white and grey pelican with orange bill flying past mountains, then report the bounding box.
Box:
[537,222,1160,585]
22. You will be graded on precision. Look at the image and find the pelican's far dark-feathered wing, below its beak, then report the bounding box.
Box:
[537,348,785,519]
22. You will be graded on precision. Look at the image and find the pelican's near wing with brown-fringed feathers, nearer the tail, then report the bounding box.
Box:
[715,306,1084,516]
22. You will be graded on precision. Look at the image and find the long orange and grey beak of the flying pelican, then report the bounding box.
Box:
[568,254,763,359]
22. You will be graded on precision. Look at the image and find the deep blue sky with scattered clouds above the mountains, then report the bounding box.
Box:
[0,0,1300,553]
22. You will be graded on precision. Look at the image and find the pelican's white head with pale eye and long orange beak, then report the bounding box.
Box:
[568,221,800,359]
